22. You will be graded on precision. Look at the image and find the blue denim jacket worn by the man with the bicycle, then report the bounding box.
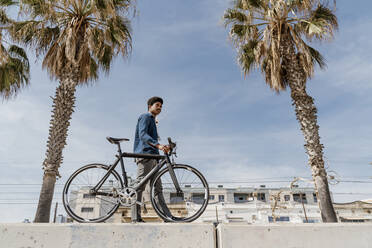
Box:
[133,113,159,154]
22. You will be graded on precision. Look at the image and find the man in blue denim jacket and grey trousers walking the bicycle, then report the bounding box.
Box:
[132,96,169,222]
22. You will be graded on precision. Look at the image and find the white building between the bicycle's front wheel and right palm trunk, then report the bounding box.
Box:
[197,185,321,224]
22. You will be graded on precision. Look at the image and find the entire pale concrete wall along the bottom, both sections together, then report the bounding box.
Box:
[0,223,372,248]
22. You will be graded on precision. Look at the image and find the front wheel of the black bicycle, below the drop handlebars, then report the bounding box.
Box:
[151,164,209,222]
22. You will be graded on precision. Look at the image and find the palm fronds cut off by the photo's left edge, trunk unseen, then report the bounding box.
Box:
[0,0,30,99]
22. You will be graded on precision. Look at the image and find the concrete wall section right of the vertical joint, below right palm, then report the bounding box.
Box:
[217,224,372,248]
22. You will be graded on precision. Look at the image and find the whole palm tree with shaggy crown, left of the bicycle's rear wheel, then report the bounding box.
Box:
[13,0,133,222]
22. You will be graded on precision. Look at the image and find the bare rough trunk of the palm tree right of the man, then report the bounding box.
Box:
[281,36,337,222]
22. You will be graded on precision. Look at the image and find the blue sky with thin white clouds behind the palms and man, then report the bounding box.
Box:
[0,0,372,223]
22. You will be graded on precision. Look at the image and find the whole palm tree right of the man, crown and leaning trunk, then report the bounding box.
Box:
[224,0,338,222]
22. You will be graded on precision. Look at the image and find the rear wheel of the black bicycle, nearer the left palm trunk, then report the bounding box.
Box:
[62,164,123,223]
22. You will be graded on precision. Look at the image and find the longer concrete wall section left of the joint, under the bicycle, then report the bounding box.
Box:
[0,223,215,248]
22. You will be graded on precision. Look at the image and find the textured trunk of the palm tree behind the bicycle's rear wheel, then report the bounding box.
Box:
[34,72,77,223]
